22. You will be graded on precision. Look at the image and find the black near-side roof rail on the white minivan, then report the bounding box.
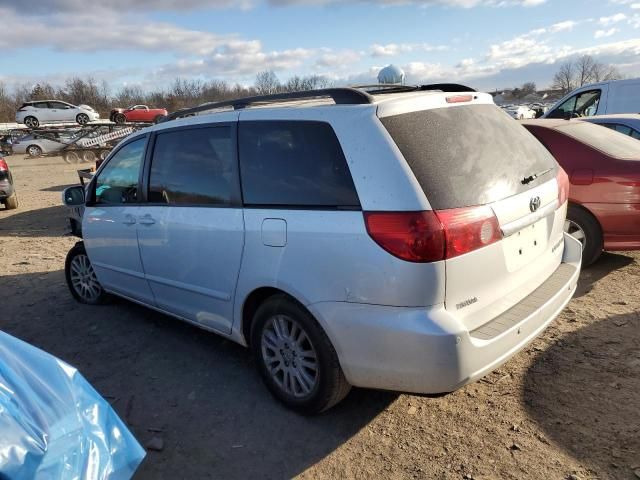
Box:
[164,88,374,122]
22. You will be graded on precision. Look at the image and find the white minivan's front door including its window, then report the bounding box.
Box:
[82,135,153,305]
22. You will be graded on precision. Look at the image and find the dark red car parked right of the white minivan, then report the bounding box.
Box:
[524,120,640,265]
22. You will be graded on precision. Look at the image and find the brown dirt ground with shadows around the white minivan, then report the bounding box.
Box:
[0,156,640,480]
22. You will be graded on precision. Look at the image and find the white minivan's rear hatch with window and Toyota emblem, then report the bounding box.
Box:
[380,103,566,330]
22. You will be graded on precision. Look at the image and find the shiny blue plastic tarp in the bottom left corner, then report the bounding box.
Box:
[0,332,145,480]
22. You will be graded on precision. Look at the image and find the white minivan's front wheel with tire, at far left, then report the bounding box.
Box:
[64,242,108,305]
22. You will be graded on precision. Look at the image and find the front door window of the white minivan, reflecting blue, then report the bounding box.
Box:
[95,138,146,205]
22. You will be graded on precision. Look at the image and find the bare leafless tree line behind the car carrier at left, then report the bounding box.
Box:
[0,71,330,123]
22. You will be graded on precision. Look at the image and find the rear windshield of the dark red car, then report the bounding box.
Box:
[558,121,640,160]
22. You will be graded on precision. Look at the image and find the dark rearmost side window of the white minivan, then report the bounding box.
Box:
[239,121,360,208]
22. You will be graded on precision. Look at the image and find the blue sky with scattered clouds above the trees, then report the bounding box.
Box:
[0,0,640,90]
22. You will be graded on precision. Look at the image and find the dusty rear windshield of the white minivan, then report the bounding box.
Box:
[380,105,556,209]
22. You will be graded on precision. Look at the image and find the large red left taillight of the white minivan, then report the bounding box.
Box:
[364,207,502,263]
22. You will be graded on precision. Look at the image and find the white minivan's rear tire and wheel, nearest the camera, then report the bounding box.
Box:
[250,295,351,414]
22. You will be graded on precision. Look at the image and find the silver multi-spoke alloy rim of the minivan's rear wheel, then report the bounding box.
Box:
[261,315,319,398]
